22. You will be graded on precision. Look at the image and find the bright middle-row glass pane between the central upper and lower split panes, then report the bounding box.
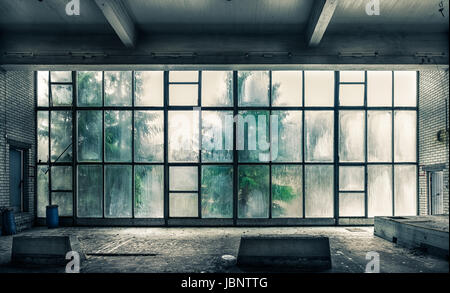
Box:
[168,111,200,162]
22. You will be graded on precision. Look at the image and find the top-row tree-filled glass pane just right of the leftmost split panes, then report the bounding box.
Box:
[77,71,103,107]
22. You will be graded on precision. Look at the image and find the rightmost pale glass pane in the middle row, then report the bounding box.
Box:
[394,111,417,162]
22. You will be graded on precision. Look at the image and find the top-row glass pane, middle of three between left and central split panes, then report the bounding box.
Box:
[105,71,131,106]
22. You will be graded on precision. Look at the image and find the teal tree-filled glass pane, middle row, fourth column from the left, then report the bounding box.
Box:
[105,111,131,162]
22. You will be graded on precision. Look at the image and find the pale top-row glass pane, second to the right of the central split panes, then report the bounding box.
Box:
[238,71,269,106]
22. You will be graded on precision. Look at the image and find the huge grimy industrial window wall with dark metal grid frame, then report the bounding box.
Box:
[36,71,418,225]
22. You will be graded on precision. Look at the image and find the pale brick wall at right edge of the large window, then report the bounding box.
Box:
[419,70,449,215]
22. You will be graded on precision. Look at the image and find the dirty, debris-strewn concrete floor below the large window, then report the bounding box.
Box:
[0,227,449,273]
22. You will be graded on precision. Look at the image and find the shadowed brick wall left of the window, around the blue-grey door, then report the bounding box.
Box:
[0,71,36,231]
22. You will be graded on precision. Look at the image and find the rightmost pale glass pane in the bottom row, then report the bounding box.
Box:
[394,165,417,216]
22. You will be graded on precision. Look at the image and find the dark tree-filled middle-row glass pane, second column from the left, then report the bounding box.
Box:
[50,111,72,162]
